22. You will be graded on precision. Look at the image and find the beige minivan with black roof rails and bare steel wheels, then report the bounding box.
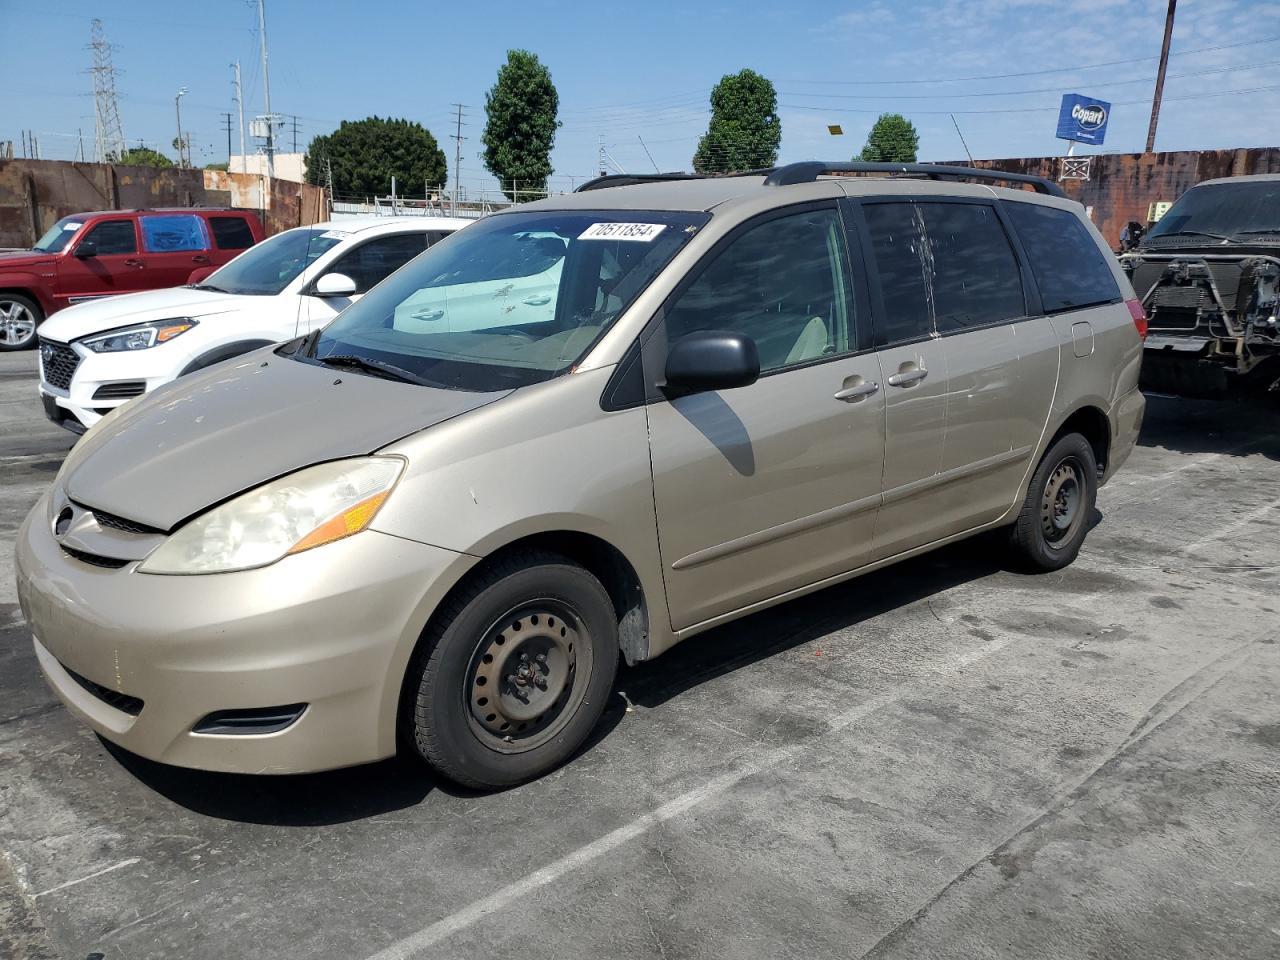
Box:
[17,163,1146,788]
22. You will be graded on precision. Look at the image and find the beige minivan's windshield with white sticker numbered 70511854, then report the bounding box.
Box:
[302,210,708,390]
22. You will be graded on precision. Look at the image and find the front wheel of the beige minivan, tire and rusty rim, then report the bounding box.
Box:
[406,550,618,790]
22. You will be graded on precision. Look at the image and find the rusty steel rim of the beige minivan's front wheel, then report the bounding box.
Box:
[462,598,591,754]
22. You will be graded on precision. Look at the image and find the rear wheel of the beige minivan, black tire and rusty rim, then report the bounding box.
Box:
[1010,434,1098,571]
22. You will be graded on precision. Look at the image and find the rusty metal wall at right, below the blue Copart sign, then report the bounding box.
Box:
[947,147,1280,248]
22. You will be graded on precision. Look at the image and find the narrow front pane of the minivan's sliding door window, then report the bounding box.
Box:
[863,204,933,347]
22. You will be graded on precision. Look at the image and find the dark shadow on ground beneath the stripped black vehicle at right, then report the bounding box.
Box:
[1138,394,1280,461]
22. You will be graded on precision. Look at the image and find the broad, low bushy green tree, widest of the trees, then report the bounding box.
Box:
[305,116,448,197]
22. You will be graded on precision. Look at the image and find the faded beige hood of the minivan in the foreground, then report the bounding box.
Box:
[59,347,509,530]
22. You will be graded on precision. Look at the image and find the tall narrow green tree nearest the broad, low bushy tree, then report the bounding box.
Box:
[481,50,561,200]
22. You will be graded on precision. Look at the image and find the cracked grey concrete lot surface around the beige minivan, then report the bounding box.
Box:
[0,355,1280,960]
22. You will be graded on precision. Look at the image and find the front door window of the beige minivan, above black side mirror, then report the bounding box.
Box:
[666,209,852,372]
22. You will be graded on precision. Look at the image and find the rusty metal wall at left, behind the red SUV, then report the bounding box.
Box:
[0,160,329,248]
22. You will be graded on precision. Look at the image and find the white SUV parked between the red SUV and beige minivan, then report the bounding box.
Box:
[40,216,471,433]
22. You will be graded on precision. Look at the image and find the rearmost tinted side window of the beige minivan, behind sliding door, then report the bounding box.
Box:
[1005,201,1120,314]
